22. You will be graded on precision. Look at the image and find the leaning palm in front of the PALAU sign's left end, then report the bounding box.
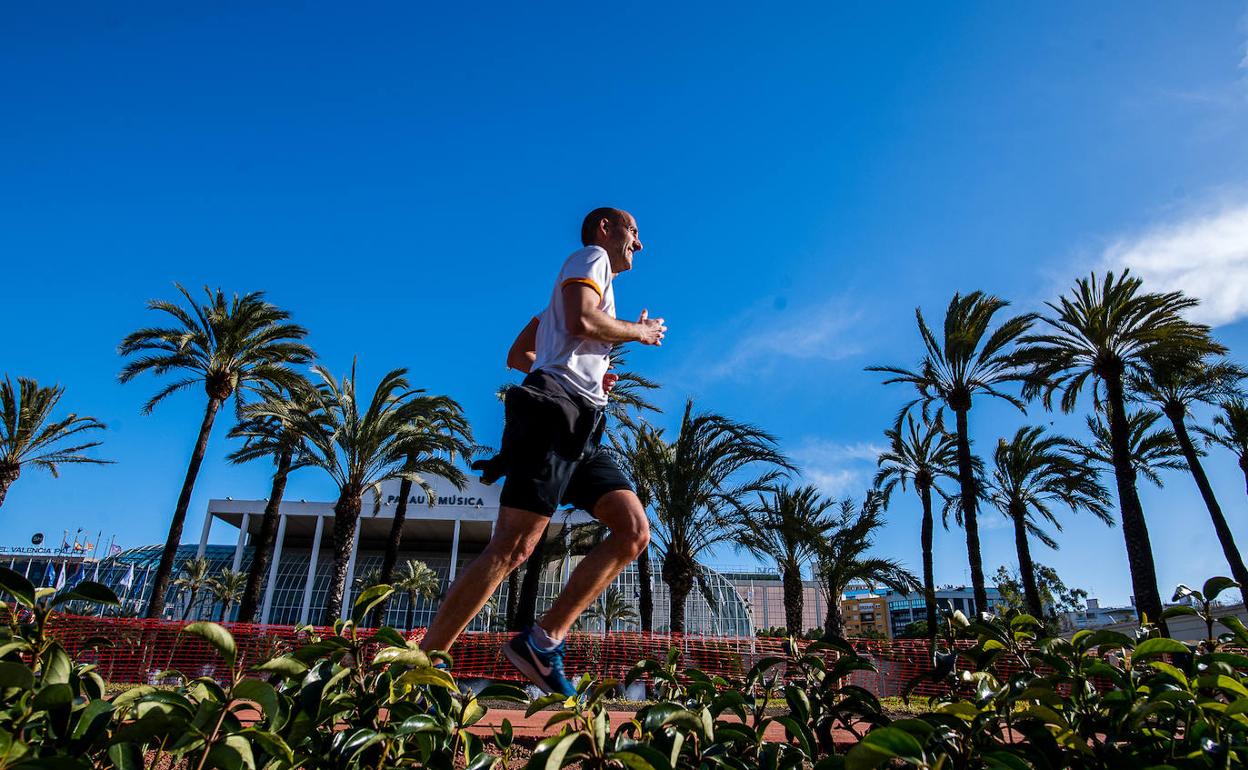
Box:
[373,397,472,624]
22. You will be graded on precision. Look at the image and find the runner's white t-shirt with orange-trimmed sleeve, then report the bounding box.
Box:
[533,246,615,407]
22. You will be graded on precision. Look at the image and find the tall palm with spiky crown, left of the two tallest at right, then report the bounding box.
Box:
[867,292,1036,612]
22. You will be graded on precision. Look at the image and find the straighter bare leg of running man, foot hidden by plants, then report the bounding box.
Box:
[421,507,550,650]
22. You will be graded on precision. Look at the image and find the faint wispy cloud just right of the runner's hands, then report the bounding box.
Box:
[709,302,862,377]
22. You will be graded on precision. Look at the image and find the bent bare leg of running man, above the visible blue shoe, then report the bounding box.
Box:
[539,489,650,641]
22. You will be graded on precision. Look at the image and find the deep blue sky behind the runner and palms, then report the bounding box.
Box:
[0,2,1248,603]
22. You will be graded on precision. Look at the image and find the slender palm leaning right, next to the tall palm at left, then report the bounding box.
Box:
[228,378,317,623]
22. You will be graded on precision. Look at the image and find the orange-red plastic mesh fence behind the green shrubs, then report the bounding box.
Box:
[43,615,973,696]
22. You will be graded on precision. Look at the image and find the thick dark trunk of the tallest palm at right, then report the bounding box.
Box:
[1104,374,1168,635]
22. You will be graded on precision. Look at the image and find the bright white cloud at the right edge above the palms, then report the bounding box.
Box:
[1104,202,1248,326]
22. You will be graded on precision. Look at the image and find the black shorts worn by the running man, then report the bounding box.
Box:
[499,371,633,515]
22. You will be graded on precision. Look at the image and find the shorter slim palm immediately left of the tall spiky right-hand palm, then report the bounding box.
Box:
[872,412,957,645]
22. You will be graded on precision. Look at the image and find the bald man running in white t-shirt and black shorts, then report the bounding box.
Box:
[421,208,668,695]
